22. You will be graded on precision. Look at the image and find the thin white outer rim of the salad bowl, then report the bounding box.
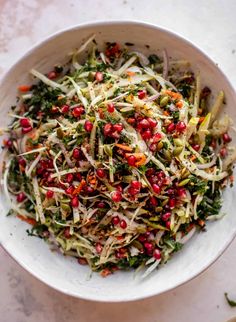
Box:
[0,19,236,303]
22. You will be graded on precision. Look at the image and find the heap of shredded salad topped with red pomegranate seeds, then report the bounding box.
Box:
[2,39,236,277]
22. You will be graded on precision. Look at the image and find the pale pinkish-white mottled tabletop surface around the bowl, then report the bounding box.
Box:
[0,0,236,322]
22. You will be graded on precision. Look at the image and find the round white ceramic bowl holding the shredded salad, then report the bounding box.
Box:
[0,22,236,302]
